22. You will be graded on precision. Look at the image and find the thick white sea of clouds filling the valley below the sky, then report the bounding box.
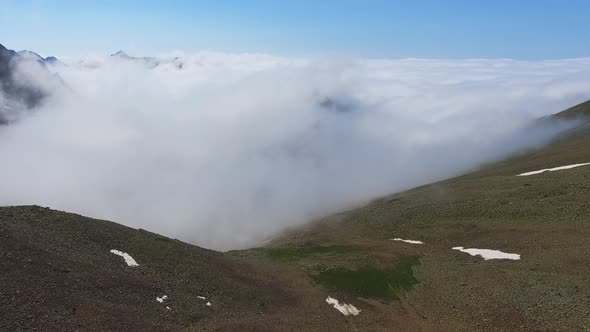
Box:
[0,52,590,250]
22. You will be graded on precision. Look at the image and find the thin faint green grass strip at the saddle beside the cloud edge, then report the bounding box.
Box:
[256,246,359,262]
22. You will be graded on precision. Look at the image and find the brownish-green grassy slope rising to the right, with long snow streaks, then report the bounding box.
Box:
[260,102,590,331]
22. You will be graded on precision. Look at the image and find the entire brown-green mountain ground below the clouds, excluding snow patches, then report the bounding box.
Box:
[0,102,590,331]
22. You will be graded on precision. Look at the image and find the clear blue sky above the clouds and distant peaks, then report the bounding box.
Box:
[0,0,590,60]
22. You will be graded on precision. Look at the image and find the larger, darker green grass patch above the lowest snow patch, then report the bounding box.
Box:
[312,256,420,303]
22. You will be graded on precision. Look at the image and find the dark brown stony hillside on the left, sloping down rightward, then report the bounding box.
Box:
[0,206,428,331]
